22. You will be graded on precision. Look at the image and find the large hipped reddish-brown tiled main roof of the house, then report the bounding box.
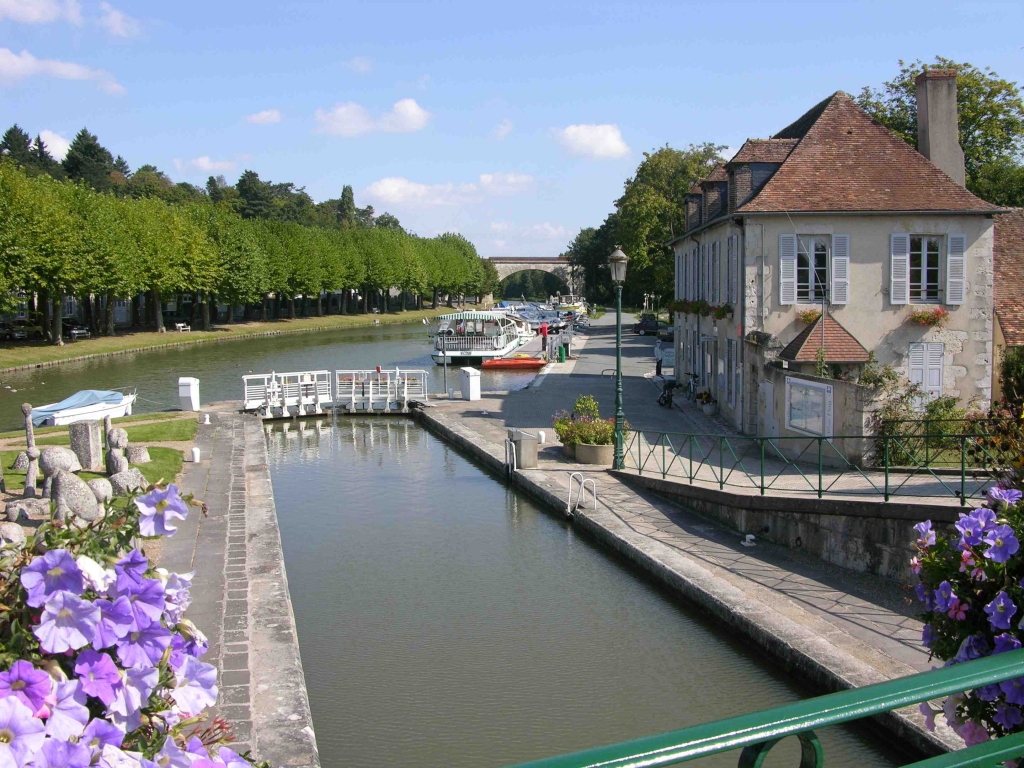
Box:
[737,91,1000,213]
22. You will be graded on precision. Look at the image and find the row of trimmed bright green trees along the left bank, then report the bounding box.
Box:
[0,162,498,343]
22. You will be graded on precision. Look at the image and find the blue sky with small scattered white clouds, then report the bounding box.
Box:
[0,0,1024,256]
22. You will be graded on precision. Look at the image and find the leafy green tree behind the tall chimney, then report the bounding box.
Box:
[857,56,1024,191]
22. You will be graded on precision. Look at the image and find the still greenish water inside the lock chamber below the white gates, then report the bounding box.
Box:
[267,417,904,768]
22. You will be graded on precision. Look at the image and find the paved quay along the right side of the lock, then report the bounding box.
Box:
[418,313,962,752]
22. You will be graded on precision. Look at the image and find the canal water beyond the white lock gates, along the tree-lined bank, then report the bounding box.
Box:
[0,323,534,430]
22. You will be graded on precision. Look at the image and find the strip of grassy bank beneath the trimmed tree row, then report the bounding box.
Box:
[0,304,471,372]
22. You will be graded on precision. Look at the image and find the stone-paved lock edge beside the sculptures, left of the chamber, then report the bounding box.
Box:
[159,406,319,766]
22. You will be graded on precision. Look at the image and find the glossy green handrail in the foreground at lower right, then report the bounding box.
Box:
[518,649,1024,768]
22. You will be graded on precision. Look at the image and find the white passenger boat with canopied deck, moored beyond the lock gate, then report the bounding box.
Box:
[430,310,525,366]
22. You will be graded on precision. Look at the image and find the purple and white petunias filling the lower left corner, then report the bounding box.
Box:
[0,484,264,768]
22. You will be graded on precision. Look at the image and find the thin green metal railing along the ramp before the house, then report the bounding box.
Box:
[625,430,1006,506]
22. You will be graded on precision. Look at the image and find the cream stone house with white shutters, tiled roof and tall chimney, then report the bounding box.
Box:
[670,70,1002,444]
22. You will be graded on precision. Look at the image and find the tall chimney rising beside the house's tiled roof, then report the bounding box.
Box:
[914,70,965,186]
